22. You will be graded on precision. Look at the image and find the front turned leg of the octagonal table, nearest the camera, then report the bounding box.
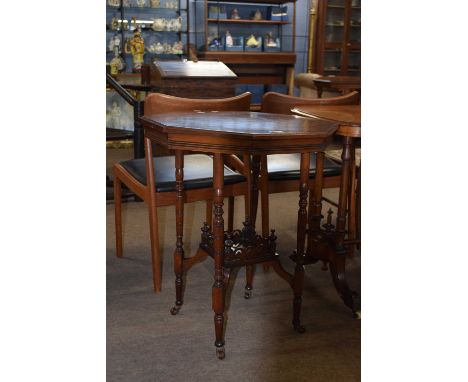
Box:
[212,154,225,359]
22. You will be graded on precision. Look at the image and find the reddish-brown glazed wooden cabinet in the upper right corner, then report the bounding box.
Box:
[313,0,361,76]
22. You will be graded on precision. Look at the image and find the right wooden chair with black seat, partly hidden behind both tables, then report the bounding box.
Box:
[260,91,360,251]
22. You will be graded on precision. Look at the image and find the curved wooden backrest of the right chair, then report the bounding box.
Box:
[262,91,361,114]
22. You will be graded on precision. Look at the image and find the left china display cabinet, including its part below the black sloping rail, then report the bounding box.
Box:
[106,0,189,131]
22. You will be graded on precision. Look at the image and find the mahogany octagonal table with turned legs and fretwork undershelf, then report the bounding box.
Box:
[140,112,338,359]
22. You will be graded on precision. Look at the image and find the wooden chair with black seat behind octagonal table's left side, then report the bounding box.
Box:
[113,92,251,293]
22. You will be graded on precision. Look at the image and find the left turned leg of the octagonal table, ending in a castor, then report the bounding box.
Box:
[171,150,184,315]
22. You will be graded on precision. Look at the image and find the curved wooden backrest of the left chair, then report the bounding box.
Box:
[145,92,252,115]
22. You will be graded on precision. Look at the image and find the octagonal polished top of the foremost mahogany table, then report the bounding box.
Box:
[140,112,338,154]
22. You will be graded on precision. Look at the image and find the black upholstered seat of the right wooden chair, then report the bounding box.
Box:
[268,154,341,180]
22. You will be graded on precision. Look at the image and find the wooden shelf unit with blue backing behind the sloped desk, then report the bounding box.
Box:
[193,0,296,104]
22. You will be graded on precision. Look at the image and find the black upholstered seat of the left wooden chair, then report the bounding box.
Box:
[120,154,245,192]
